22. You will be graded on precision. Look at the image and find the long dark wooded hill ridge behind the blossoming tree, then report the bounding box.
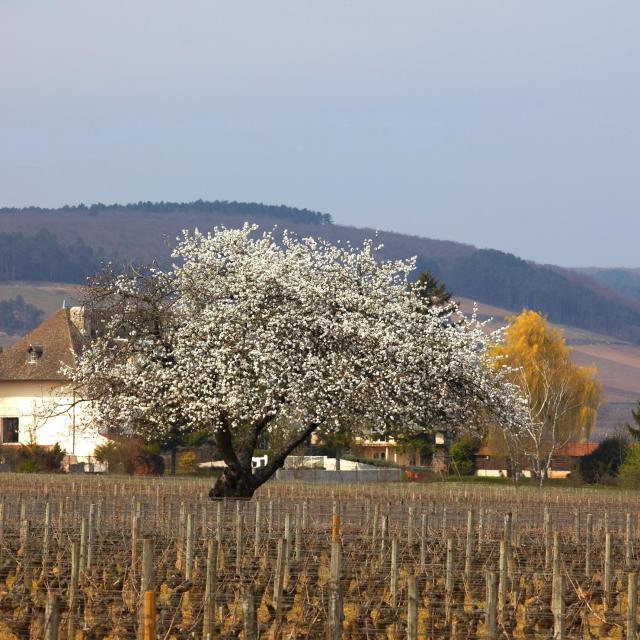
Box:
[0,200,640,343]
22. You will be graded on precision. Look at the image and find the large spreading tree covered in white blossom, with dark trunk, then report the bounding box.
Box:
[70,225,523,497]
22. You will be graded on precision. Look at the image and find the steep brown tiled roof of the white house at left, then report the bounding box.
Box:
[0,309,83,380]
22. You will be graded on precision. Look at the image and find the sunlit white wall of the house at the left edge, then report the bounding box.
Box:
[0,381,105,461]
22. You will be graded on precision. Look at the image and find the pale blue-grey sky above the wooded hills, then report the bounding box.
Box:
[0,0,640,267]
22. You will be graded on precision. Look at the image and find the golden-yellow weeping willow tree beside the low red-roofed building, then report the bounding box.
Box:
[493,310,602,486]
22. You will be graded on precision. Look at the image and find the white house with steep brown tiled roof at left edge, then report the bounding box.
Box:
[0,307,104,464]
